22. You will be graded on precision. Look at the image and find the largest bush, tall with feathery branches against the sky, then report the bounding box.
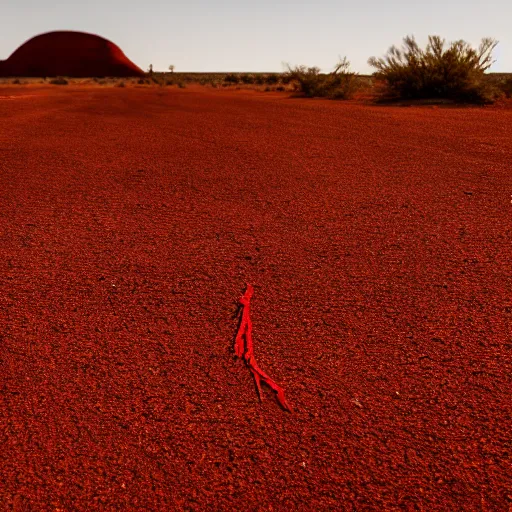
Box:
[368,36,498,103]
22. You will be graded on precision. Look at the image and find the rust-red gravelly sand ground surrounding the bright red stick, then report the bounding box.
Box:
[0,87,512,511]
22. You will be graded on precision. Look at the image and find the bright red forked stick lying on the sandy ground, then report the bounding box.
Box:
[235,284,292,412]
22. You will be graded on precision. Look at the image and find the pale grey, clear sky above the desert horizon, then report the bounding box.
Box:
[0,0,512,73]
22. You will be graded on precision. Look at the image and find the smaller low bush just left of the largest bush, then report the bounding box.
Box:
[285,58,359,99]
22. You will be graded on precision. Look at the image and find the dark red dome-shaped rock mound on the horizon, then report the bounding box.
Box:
[0,31,144,78]
